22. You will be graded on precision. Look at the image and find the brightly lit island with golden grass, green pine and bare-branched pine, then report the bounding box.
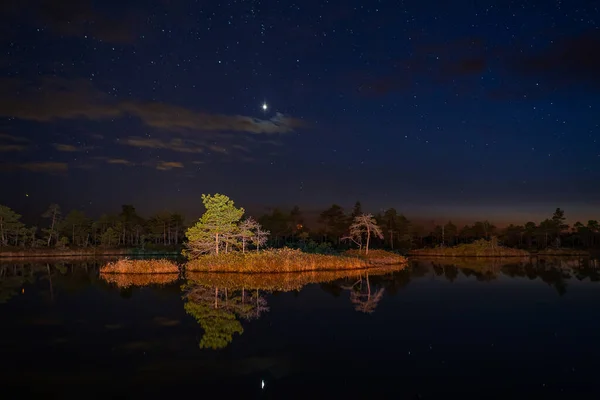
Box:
[184,194,407,273]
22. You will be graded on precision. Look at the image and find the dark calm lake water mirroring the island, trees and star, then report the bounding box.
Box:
[0,259,600,399]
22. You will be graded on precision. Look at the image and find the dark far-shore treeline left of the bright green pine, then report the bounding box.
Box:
[0,204,184,248]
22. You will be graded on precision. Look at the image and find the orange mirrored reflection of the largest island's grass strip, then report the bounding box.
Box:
[185,264,406,292]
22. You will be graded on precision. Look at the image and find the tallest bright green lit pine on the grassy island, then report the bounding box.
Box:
[185,193,244,256]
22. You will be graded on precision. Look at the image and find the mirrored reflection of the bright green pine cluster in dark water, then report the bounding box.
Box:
[184,283,269,350]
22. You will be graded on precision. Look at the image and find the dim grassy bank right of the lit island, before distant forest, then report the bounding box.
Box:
[410,239,530,257]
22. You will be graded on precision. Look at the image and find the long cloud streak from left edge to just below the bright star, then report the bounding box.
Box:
[0,77,305,134]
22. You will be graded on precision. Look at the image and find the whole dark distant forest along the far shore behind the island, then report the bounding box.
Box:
[0,202,600,253]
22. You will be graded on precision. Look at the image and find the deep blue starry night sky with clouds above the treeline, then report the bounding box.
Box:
[0,0,600,223]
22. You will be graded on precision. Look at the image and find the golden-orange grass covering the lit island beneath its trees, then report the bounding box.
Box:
[185,248,406,273]
